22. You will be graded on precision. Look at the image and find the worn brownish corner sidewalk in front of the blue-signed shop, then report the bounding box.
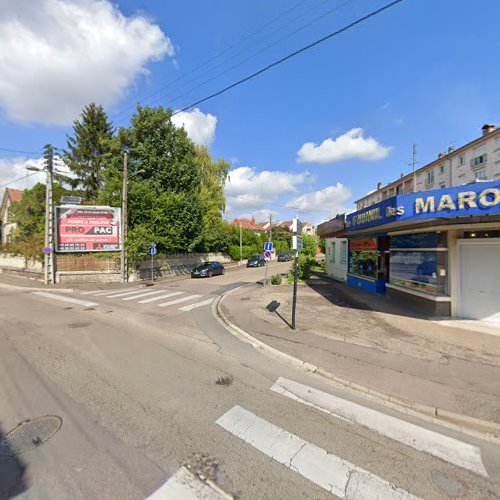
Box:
[221,279,500,423]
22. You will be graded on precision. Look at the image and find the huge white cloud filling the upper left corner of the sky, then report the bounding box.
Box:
[0,0,175,125]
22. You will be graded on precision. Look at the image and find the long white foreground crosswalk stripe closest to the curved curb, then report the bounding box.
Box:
[271,377,488,477]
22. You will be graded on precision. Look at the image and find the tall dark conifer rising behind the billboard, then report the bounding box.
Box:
[63,103,113,201]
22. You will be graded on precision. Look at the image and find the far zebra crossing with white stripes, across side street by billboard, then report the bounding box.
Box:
[38,287,215,312]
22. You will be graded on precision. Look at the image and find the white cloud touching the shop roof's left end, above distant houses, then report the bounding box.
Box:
[287,182,352,221]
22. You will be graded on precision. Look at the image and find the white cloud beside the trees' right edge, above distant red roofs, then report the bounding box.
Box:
[225,167,312,212]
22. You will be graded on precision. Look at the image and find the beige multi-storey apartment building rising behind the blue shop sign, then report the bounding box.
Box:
[356,125,500,210]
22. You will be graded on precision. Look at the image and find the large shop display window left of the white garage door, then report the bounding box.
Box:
[389,232,448,295]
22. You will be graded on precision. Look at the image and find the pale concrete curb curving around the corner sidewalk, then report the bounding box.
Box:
[212,283,500,444]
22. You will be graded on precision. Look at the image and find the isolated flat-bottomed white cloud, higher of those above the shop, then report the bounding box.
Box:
[297,128,392,163]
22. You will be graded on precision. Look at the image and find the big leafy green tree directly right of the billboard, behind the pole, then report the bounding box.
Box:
[99,106,203,262]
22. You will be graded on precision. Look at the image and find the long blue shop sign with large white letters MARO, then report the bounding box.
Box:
[346,181,500,232]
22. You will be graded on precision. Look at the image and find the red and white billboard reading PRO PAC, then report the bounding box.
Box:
[55,205,121,252]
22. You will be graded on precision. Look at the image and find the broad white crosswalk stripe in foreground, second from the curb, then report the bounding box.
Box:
[216,406,417,500]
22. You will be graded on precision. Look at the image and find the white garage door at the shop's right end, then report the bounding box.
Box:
[458,239,500,323]
